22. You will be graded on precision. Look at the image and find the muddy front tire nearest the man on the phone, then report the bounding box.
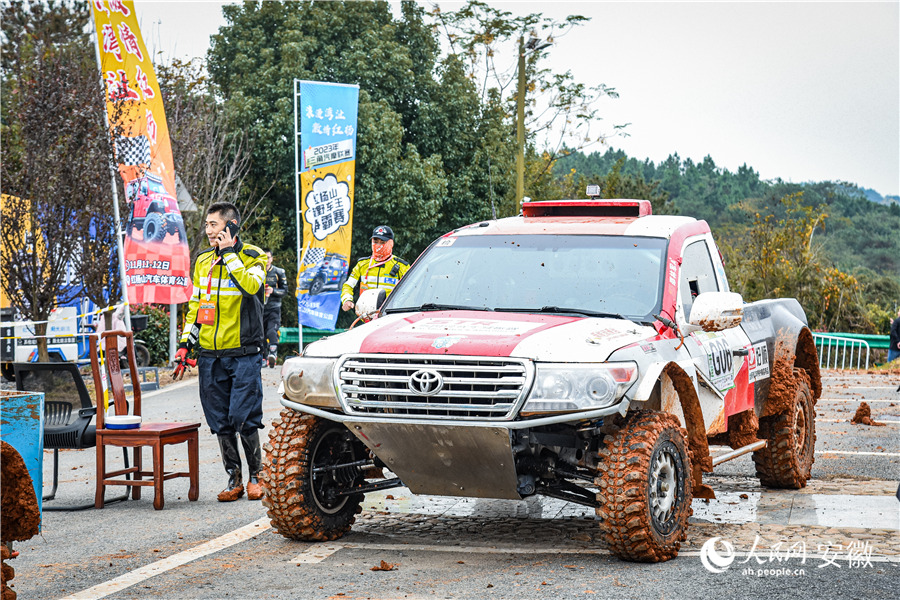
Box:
[262,408,367,541]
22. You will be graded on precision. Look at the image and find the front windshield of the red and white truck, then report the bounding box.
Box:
[385,235,666,322]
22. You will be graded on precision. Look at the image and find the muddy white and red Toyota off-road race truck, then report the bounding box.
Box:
[263,200,821,561]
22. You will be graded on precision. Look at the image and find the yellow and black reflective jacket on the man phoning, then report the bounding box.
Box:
[181,239,266,356]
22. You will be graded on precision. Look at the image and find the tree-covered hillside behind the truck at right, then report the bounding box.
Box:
[554,149,900,333]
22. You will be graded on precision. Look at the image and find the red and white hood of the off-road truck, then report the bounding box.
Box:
[305,311,656,362]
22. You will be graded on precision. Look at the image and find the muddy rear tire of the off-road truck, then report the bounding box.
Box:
[753,368,816,489]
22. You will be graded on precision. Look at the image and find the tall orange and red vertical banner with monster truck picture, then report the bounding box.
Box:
[91,0,191,304]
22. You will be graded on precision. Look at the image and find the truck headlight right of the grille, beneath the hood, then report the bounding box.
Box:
[522,362,638,414]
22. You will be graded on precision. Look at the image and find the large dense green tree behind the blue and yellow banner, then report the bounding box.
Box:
[209,2,513,274]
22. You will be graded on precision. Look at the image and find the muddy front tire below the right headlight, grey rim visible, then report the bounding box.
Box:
[596,410,693,562]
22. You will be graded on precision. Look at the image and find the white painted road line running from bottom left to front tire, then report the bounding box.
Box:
[62,517,271,600]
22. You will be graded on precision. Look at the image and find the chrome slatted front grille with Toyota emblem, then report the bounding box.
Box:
[338,354,534,420]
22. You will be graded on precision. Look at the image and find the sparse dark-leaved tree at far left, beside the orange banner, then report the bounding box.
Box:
[0,2,118,360]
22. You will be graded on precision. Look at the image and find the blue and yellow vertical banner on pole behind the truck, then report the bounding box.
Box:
[294,80,359,330]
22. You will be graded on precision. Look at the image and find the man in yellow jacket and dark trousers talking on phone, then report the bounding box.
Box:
[175,202,266,502]
